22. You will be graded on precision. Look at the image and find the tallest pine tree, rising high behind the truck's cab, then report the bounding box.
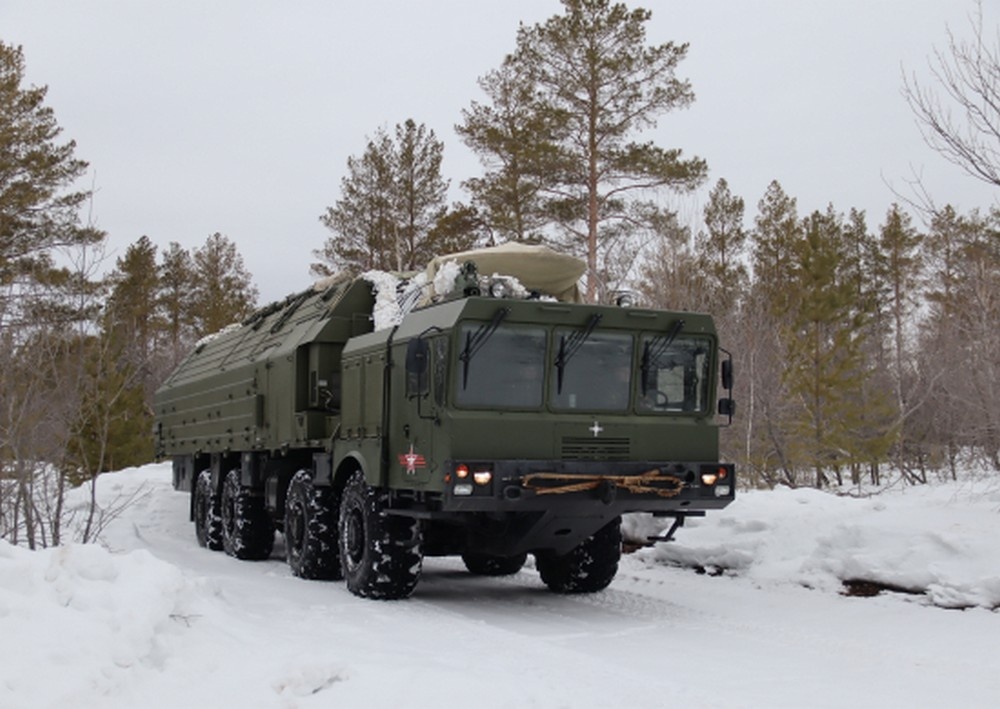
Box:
[466,0,707,302]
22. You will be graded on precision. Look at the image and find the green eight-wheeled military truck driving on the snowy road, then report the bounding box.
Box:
[155,245,735,598]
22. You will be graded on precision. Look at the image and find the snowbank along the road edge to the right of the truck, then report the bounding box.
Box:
[626,484,1000,609]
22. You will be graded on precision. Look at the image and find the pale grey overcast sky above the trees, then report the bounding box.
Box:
[0,0,996,301]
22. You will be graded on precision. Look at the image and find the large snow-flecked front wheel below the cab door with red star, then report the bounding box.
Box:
[339,471,423,599]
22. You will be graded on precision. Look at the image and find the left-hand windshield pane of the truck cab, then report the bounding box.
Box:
[455,323,546,409]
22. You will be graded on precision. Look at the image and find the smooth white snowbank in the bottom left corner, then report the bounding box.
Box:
[0,540,185,708]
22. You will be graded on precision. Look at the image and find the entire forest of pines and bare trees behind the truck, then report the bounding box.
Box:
[0,0,1000,546]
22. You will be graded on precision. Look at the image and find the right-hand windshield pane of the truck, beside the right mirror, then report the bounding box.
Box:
[638,335,712,413]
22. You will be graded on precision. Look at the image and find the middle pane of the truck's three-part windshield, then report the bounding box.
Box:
[549,329,632,411]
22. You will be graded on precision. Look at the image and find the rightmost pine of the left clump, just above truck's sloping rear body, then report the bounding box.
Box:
[190,232,257,337]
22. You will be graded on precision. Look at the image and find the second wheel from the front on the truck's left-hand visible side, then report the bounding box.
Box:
[285,470,343,579]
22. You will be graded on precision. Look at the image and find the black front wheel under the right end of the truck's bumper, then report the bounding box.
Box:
[535,517,622,593]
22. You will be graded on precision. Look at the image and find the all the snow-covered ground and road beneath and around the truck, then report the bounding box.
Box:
[0,465,1000,709]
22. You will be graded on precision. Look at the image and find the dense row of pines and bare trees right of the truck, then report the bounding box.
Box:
[640,180,1000,487]
